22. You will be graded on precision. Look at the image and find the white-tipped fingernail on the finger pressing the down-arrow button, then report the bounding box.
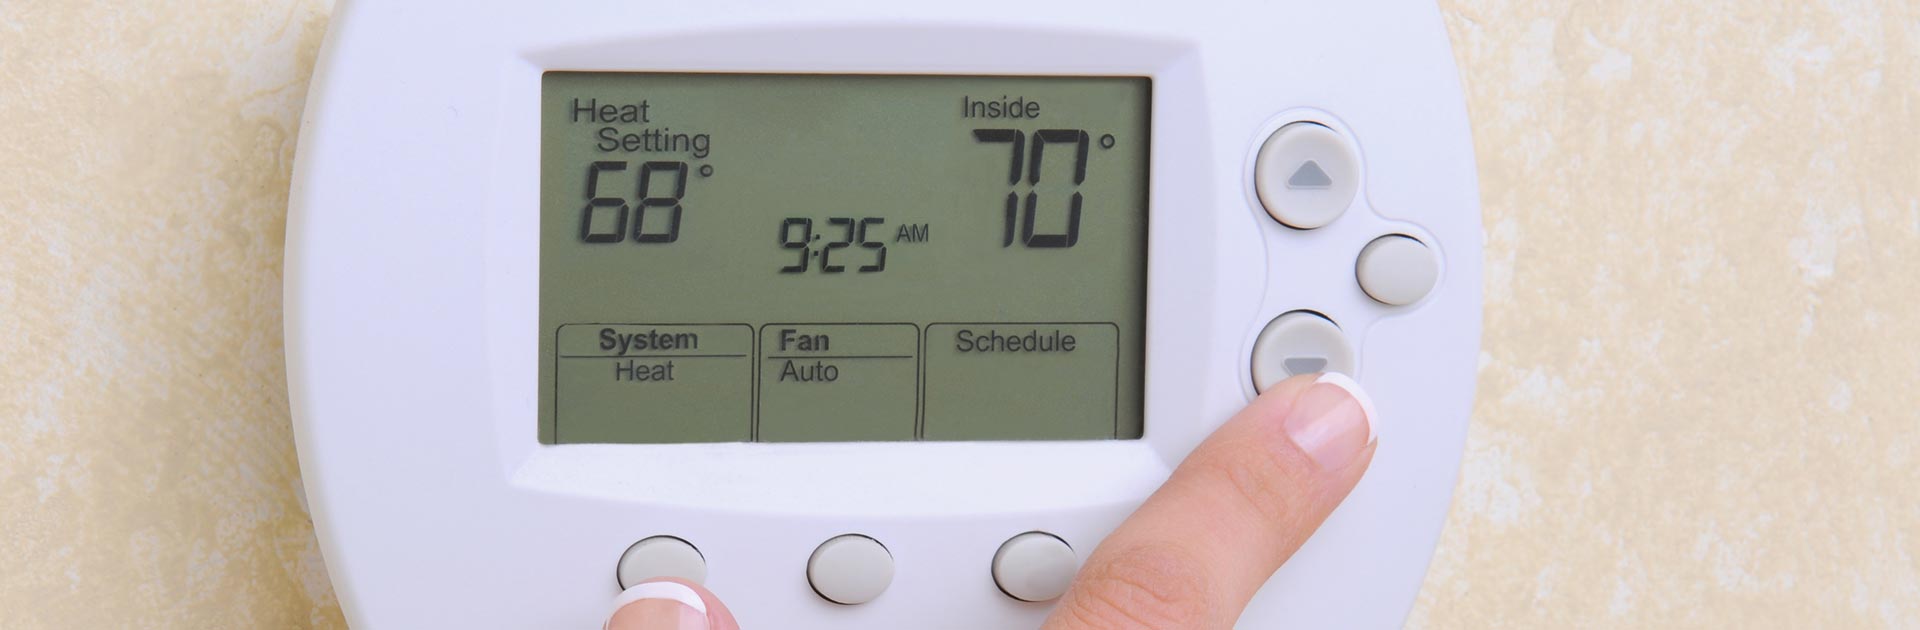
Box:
[1286,373,1379,471]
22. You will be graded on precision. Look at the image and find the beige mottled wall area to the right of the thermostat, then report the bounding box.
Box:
[1413,0,1920,628]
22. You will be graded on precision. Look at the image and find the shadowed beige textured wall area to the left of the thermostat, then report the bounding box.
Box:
[0,0,342,628]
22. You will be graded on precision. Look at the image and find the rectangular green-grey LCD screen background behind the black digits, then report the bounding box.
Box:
[540,71,1152,444]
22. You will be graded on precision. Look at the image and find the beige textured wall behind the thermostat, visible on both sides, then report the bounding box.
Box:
[0,0,1920,628]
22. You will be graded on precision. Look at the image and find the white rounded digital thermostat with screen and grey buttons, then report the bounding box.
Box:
[286,0,1480,630]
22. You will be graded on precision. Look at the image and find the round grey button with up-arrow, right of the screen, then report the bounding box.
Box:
[1254,123,1359,230]
